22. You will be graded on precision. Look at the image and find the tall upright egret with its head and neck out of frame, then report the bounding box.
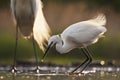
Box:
[11,0,50,72]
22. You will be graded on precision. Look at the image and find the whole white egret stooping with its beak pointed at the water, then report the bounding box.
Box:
[42,14,107,74]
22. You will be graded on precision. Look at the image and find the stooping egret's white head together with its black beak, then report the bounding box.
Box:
[42,35,61,61]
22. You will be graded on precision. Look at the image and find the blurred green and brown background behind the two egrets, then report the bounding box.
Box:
[0,0,120,64]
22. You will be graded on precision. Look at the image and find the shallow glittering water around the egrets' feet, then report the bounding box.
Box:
[0,67,120,80]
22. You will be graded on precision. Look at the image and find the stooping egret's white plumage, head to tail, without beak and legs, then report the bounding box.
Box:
[48,15,107,53]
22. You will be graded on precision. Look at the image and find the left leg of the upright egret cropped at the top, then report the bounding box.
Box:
[11,25,18,73]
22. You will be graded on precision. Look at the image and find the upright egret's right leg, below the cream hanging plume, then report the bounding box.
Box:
[32,36,40,73]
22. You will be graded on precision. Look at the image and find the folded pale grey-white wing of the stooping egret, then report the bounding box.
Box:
[63,22,106,44]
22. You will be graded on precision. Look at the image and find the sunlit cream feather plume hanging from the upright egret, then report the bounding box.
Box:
[33,0,50,51]
